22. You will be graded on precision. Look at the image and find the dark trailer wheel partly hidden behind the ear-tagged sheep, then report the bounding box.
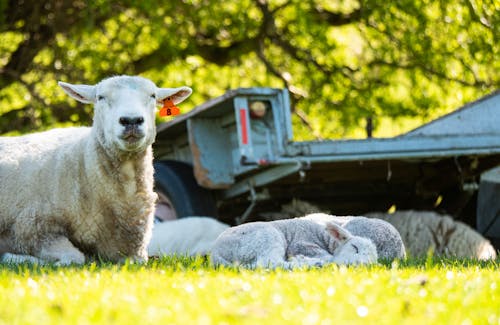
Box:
[154,160,217,220]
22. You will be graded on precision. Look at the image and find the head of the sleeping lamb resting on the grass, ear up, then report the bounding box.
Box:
[326,222,378,264]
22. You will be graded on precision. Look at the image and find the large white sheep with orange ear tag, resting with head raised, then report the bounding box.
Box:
[0,76,192,265]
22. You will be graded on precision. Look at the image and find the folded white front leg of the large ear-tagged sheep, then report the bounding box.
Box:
[37,236,85,265]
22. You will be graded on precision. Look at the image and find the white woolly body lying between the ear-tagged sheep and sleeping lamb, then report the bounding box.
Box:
[148,217,229,256]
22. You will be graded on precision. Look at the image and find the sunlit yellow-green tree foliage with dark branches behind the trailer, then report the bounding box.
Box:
[0,0,500,138]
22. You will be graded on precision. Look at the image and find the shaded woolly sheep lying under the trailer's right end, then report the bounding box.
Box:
[366,210,497,260]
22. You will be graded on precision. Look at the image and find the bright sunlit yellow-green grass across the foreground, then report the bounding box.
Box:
[0,258,500,325]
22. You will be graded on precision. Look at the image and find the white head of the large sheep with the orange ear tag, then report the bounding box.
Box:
[59,76,191,152]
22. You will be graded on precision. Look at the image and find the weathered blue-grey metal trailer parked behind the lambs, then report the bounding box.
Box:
[154,88,500,246]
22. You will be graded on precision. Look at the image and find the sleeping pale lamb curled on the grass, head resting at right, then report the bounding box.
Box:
[211,219,377,269]
